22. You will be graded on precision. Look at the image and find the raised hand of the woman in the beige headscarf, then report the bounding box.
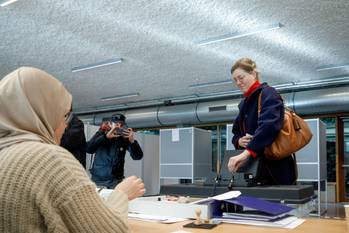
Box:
[115,176,145,201]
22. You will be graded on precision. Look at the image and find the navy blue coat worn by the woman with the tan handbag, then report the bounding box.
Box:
[232,83,296,185]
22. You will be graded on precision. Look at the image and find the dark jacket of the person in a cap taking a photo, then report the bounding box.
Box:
[87,130,143,184]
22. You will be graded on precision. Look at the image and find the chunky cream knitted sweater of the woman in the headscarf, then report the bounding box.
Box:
[0,142,128,233]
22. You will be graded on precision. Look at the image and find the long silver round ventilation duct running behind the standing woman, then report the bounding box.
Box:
[81,86,349,128]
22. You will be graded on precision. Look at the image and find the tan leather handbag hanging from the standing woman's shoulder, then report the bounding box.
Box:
[258,92,313,160]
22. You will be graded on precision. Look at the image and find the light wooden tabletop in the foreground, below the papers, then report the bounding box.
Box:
[129,218,349,233]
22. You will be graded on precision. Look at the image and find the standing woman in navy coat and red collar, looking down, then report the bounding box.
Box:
[228,58,297,185]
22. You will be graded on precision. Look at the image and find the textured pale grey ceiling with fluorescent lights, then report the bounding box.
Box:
[0,0,349,111]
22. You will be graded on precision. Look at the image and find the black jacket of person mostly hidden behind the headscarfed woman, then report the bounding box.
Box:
[61,115,86,168]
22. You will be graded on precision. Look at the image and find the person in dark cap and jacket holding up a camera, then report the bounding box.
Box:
[86,114,143,188]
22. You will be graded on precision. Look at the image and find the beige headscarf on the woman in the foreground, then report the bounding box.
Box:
[0,67,72,150]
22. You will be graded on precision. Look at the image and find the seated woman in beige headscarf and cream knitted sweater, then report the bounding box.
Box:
[0,67,145,232]
